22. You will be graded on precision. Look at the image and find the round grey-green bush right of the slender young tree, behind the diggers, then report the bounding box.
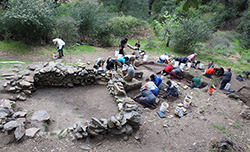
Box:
[171,19,211,53]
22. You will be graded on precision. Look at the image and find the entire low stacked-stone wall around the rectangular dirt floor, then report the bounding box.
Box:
[0,62,141,140]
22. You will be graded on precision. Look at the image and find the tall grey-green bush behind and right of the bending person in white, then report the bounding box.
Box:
[70,2,111,46]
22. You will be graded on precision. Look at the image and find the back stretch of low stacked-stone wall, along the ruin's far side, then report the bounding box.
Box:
[2,62,111,100]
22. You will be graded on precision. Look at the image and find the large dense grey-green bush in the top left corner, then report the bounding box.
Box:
[2,0,55,44]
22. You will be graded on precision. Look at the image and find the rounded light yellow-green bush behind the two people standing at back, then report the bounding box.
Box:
[109,15,141,37]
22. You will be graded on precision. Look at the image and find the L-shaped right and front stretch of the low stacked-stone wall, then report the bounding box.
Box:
[66,72,141,139]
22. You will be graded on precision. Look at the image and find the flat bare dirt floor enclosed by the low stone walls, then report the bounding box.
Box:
[16,85,117,131]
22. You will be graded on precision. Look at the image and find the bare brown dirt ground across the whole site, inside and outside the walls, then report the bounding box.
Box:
[0,48,250,152]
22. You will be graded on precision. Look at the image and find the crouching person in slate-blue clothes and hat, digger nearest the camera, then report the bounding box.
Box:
[133,86,156,108]
